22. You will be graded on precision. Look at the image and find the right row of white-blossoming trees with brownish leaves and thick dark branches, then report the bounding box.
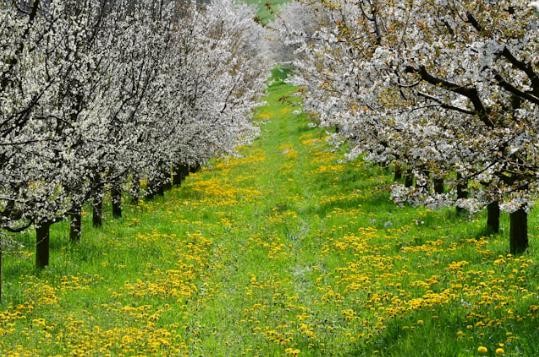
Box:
[288,0,539,253]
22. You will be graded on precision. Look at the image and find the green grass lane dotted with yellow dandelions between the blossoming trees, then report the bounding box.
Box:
[0,70,539,356]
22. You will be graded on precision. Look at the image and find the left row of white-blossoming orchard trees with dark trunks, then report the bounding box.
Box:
[0,0,266,300]
